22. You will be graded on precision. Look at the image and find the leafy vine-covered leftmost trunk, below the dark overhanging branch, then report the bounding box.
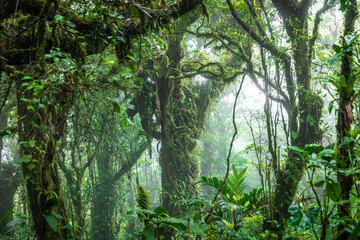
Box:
[16,76,72,239]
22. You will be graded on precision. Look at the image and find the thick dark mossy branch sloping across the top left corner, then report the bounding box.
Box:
[0,0,202,65]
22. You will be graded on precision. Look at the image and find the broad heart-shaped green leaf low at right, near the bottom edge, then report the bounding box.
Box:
[288,204,320,232]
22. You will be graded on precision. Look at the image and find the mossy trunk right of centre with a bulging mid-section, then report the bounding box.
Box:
[273,3,323,226]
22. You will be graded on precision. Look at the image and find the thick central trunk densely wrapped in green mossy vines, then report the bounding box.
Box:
[156,26,225,216]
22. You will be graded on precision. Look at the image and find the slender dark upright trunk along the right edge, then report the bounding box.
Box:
[336,0,359,239]
